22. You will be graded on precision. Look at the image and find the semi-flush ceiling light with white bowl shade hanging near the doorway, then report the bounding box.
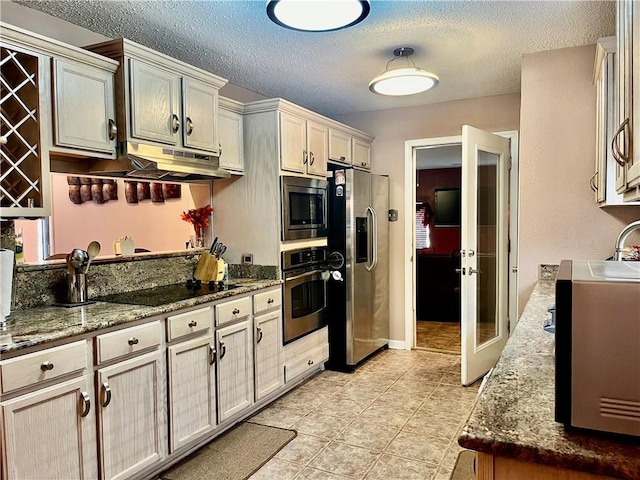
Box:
[369,47,440,96]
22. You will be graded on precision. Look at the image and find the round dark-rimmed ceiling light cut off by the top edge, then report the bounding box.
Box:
[267,0,371,32]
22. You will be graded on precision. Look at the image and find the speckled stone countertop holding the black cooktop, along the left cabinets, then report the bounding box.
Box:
[0,278,282,355]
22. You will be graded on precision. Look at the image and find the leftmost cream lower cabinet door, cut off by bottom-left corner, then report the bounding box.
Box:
[0,377,98,480]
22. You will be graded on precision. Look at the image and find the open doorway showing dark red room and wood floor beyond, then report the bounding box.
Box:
[414,144,462,355]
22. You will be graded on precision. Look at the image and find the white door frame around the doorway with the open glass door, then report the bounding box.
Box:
[404,130,519,350]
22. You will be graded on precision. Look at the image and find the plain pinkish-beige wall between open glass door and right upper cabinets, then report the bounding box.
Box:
[518,45,640,311]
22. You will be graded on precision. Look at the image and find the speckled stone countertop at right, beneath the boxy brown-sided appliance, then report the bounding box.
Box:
[458,280,640,480]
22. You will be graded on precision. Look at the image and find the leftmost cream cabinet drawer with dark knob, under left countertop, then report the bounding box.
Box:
[0,341,87,393]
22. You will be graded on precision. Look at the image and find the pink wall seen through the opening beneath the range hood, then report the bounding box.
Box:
[51,174,215,256]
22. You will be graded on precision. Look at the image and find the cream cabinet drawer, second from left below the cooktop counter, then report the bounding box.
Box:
[96,321,162,363]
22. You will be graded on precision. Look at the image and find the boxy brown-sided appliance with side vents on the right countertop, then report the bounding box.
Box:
[555,260,640,437]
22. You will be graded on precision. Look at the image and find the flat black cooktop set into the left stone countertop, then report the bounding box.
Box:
[95,280,240,307]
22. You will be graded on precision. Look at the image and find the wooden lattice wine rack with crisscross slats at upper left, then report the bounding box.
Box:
[0,45,50,217]
